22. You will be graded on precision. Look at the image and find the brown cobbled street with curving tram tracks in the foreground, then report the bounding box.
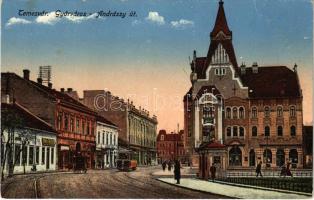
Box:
[1,168,226,199]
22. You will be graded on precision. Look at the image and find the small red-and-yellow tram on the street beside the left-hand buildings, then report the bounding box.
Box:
[117,150,137,171]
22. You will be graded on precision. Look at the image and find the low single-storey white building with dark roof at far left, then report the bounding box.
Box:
[1,103,57,174]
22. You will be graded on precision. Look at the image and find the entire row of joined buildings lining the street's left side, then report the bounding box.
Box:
[1,70,157,175]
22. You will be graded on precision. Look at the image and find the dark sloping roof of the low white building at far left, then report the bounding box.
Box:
[1,103,56,133]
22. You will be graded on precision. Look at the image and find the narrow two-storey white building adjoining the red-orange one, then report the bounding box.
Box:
[95,116,118,169]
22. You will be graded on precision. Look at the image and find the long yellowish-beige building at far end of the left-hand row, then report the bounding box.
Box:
[81,90,157,165]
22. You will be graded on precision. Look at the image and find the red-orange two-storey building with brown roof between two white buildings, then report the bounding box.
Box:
[1,70,97,169]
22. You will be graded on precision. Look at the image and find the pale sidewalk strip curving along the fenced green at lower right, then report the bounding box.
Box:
[157,178,311,199]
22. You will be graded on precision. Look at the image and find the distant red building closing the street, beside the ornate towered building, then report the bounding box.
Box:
[157,130,187,163]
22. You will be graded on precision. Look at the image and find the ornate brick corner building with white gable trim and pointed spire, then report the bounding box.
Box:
[183,1,303,172]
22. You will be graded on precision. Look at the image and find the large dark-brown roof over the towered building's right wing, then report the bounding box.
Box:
[240,66,302,98]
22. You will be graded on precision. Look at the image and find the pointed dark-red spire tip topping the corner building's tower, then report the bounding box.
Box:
[210,1,232,36]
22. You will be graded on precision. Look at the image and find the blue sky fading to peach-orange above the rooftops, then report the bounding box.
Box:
[1,0,313,131]
